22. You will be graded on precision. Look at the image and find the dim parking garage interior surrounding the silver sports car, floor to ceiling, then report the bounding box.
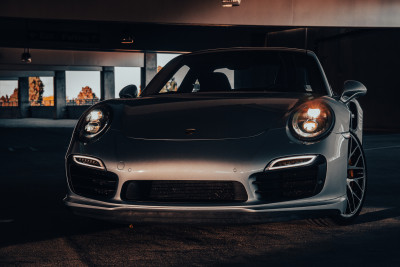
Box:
[0,0,400,266]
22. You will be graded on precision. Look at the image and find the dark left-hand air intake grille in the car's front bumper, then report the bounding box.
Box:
[68,164,118,199]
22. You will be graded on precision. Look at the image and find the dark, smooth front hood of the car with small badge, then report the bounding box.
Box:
[117,94,310,140]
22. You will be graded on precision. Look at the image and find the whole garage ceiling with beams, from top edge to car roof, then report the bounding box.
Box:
[0,0,400,78]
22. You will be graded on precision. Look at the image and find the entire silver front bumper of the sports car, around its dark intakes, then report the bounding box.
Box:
[64,129,347,224]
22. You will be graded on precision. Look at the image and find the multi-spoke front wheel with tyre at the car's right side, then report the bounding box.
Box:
[332,133,367,225]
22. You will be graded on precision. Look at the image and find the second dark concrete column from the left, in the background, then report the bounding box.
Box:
[54,71,67,119]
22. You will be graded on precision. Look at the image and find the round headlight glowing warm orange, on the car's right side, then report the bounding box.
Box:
[289,101,334,141]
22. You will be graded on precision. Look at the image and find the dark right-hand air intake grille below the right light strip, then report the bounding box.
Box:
[255,156,326,203]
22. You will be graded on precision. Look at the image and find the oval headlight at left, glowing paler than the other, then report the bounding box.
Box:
[77,105,111,142]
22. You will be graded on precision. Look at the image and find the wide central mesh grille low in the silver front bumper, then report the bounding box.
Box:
[121,180,247,202]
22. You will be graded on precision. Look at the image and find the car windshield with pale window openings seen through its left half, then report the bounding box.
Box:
[146,50,328,95]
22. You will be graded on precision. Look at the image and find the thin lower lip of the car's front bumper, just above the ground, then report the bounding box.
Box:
[64,196,346,224]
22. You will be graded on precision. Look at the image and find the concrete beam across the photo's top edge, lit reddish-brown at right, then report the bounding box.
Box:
[0,0,400,27]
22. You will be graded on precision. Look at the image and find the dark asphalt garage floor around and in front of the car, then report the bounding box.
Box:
[0,127,400,266]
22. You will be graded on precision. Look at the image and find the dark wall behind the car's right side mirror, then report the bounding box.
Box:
[317,29,400,130]
